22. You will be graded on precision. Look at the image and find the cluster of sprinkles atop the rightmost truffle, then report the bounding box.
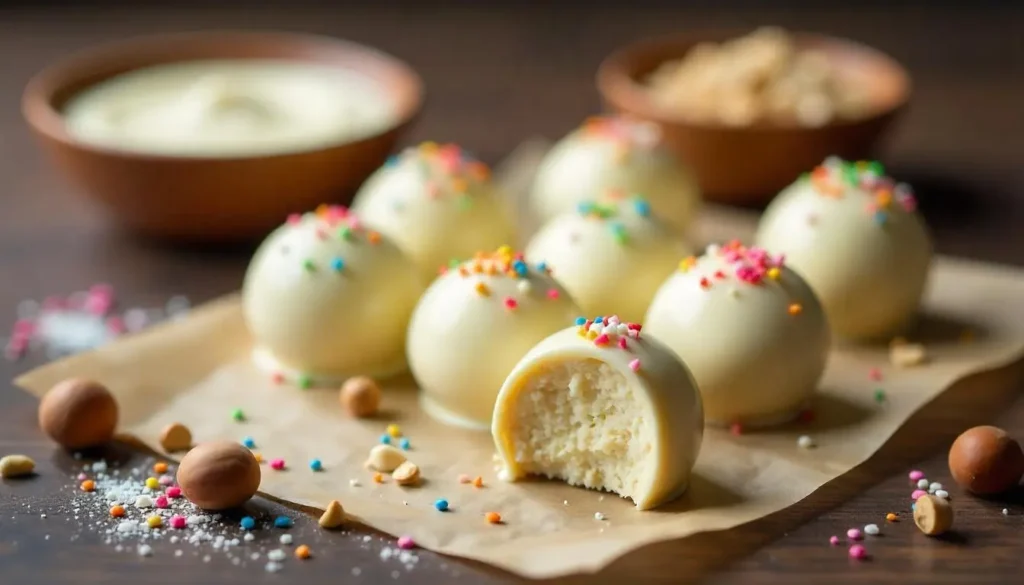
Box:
[801,157,918,225]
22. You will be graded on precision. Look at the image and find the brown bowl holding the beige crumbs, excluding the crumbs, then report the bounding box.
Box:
[597,31,910,205]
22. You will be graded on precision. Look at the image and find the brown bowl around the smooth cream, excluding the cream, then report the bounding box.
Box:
[22,32,423,242]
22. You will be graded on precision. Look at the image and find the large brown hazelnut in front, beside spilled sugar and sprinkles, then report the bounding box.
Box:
[178,441,260,510]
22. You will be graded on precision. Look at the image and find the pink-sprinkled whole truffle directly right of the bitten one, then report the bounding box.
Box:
[644,242,829,426]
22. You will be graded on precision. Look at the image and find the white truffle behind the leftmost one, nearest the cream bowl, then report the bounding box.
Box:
[352,142,515,279]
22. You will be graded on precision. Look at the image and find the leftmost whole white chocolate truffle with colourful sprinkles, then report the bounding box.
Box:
[242,206,424,386]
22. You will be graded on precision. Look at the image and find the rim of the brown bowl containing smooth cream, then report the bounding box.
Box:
[22,29,425,163]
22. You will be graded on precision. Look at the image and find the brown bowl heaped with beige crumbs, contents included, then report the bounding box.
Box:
[597,27,910,205]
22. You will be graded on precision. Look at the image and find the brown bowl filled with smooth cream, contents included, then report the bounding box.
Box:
[22,31,423,242]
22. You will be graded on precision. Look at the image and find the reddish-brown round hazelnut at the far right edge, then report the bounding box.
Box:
[949,426,1024,496]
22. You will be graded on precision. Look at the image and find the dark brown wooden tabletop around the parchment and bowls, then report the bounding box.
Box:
[0,1,1024,585]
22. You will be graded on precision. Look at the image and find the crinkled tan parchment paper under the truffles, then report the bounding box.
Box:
[15,143,1024,578]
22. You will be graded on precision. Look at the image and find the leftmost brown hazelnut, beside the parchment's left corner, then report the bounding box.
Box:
[39,378,118,450]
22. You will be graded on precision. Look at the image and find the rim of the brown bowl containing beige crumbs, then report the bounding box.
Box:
[595,28,912,134]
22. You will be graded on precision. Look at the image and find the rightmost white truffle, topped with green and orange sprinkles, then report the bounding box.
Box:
[757,159,932,340]
